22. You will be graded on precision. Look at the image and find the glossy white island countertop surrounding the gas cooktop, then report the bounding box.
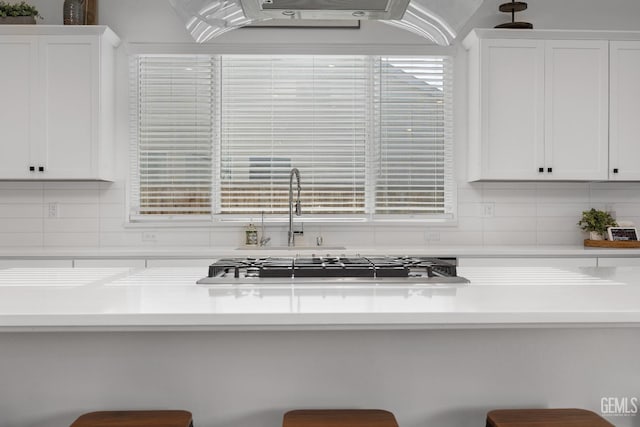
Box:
[0,267,640,331]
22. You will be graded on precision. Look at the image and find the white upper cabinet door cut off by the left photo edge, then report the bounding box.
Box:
[0,36,40,179]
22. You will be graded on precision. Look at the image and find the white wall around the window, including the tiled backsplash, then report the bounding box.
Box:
[0,0,640,248]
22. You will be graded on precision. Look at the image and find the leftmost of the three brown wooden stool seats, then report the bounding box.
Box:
[71,411,193,427]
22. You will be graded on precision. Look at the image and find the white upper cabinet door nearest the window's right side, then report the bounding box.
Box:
[480,40,544,179]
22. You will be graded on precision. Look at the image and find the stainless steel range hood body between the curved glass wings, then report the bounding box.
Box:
[242,0,409,20]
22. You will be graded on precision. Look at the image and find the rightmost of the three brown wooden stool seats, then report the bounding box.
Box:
[487,409,614,427]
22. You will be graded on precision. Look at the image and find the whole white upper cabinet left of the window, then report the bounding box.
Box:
[0,25,119,180]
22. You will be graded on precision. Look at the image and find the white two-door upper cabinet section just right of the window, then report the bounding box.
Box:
[464,30,609,181]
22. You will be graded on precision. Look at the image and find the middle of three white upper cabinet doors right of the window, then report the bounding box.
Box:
[545,40,609,180]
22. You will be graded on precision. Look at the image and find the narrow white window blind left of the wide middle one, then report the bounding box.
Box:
[130,55,217,218]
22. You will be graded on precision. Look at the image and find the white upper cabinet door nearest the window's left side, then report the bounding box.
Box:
[40,36,100,179]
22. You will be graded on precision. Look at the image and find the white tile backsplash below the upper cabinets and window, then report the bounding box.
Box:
[0,182,640,248]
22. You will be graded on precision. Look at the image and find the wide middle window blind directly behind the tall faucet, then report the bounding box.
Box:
[219,56,370,214]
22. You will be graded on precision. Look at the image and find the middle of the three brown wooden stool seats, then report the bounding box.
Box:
[282,409,398,427]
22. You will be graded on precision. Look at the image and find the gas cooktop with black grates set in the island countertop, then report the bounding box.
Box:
[198,255,468,284]
